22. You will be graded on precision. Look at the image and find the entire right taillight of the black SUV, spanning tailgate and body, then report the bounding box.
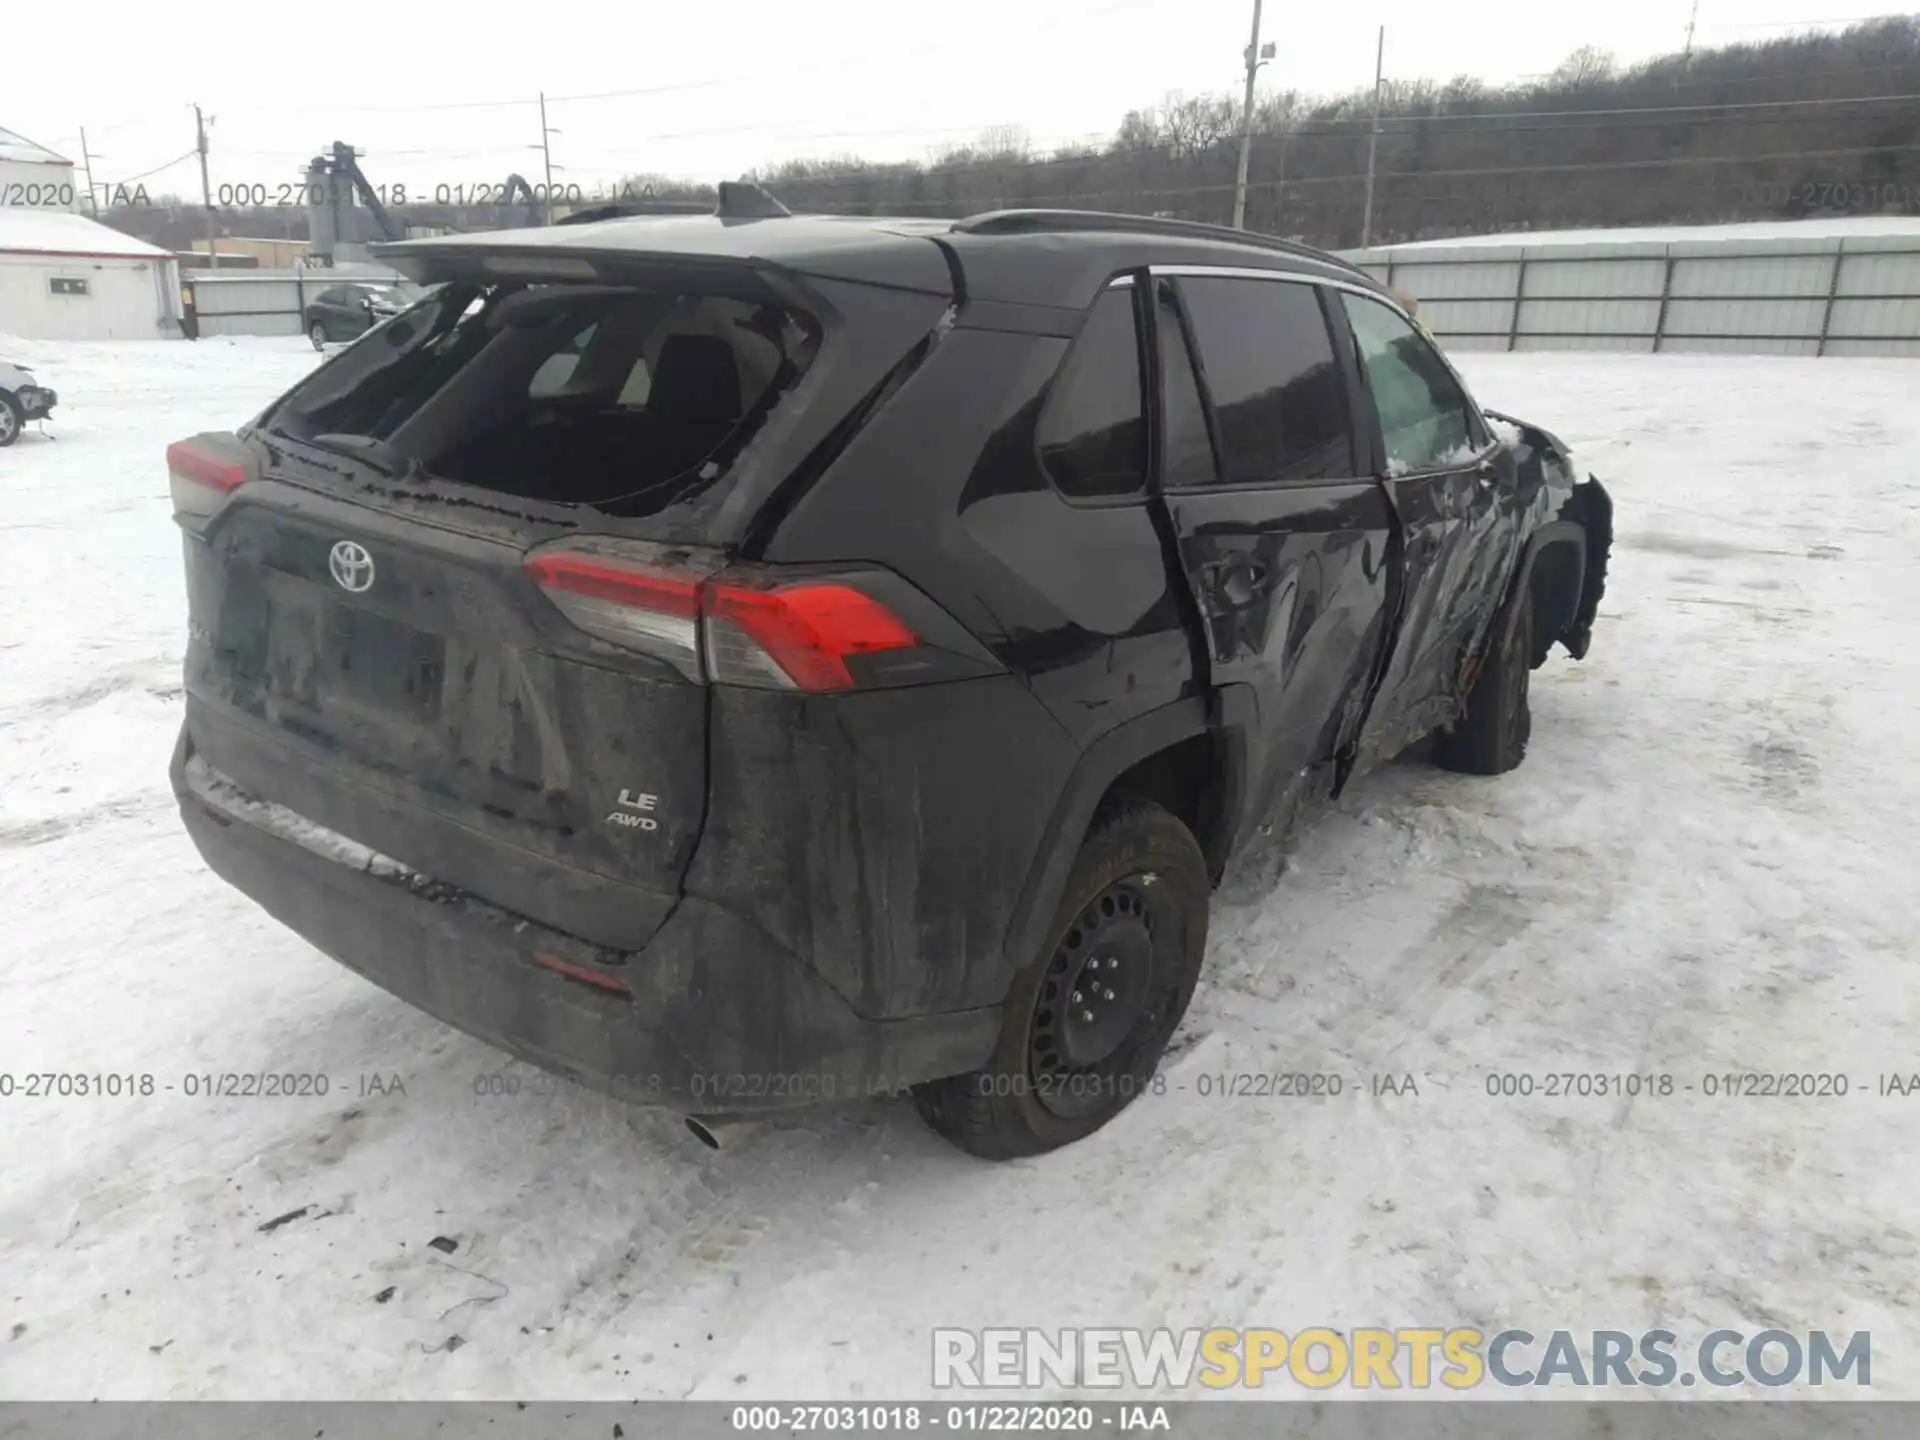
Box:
[526,545,925,693]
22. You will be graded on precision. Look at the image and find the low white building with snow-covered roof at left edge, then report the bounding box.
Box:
[0,205,180,340]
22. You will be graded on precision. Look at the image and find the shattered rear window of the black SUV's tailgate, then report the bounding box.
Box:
[263,282,820,516]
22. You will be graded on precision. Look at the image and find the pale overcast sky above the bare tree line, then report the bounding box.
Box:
[11,0,1904,196]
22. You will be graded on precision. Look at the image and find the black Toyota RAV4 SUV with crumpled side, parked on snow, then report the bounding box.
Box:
[167,200,1611,1156]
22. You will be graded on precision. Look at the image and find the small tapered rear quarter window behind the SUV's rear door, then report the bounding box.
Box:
[1039,290,1146,495]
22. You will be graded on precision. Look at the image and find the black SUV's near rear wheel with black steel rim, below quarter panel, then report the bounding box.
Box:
[914,797,1212,1160]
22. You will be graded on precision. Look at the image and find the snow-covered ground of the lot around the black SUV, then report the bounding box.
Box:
[0,342,1920,1398]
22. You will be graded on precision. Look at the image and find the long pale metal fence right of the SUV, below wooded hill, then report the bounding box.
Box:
[1346,234,1920,357]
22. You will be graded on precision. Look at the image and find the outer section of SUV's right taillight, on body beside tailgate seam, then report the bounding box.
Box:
[703,582,920,691]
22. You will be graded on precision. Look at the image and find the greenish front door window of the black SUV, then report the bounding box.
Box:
[1340,292,1484,470]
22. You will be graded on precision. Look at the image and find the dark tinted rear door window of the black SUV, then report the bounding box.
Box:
[1181,278,1354,486]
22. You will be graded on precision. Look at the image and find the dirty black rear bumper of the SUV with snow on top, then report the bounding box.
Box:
[173,730,998,1114]
